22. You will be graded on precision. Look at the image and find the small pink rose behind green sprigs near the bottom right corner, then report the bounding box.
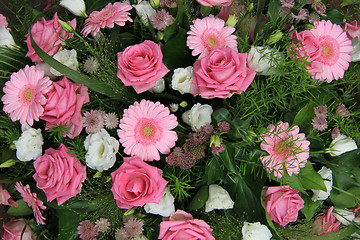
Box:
[311,206,341,235]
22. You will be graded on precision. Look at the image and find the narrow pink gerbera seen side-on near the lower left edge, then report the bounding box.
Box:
[15,182,46,225]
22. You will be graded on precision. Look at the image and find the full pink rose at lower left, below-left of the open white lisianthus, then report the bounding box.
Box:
[33,144,86,205]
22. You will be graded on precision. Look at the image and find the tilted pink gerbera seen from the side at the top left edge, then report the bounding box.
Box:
[81,2,132,37]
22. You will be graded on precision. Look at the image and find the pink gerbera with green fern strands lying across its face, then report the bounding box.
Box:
[259,122,310,178]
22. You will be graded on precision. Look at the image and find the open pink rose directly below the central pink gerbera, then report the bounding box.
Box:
[111,156,168,209]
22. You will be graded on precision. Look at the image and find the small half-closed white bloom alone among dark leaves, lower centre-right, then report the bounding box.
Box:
[205,184,234,212]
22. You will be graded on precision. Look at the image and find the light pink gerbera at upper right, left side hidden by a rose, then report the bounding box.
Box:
[309,20,353,82]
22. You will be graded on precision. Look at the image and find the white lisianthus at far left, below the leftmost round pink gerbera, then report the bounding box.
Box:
[14,123,44,162]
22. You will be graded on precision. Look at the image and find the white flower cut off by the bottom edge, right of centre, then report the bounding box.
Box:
[241,222,272,240]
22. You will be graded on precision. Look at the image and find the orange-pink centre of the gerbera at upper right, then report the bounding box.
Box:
[320,36,340,65]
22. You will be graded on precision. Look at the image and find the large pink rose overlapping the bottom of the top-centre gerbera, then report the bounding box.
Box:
[190,48,256,98]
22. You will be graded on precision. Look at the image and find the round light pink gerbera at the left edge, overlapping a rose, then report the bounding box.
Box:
[1,65,52,126]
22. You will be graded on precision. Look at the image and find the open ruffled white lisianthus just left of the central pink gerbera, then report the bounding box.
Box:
[84,129,119,172]
